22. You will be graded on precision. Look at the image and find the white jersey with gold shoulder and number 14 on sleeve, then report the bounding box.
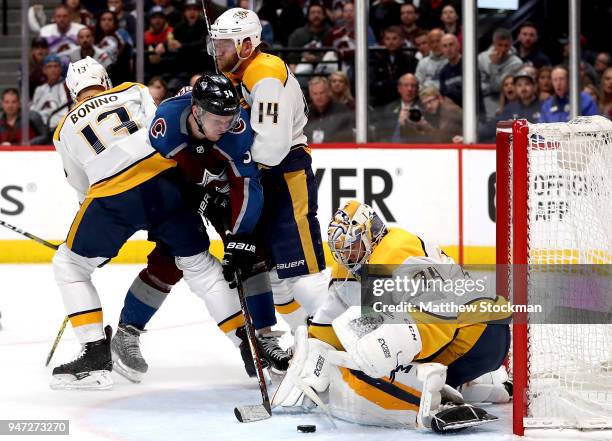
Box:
[228,53,308,167]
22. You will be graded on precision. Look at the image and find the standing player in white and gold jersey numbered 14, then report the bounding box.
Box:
[208,8,334,329]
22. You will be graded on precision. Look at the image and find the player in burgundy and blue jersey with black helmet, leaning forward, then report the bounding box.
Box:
[112,75,289,382]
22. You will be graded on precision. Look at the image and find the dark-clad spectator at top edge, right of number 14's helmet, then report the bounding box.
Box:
[285,3,331,73]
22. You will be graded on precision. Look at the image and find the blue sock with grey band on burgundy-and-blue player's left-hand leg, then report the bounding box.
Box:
[119,269,172,330]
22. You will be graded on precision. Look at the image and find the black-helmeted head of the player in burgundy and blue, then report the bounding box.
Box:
[191,74,240,141]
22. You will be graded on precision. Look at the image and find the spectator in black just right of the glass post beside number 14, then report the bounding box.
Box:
[370,26,418,106]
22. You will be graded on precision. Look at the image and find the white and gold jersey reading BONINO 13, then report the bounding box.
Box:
[53,83,176,200]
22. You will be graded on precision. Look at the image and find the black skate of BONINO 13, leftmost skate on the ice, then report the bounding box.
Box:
[51,326,113,390]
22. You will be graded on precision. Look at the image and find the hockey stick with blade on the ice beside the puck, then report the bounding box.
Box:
[234,270,272,423]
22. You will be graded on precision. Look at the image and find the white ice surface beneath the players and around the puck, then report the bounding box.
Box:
[0,264,608,441]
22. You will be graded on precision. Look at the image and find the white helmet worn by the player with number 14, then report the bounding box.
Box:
[210,8,261,53]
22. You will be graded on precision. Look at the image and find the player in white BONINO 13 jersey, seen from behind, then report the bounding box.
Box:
[51,57,245,389]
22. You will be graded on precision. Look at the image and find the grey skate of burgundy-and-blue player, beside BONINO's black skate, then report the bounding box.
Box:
[111,323,149,383]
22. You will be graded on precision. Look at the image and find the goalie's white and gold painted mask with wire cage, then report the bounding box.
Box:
[327,200,387,275]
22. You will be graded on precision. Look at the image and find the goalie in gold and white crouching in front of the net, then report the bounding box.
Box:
[272,201,511,432]
